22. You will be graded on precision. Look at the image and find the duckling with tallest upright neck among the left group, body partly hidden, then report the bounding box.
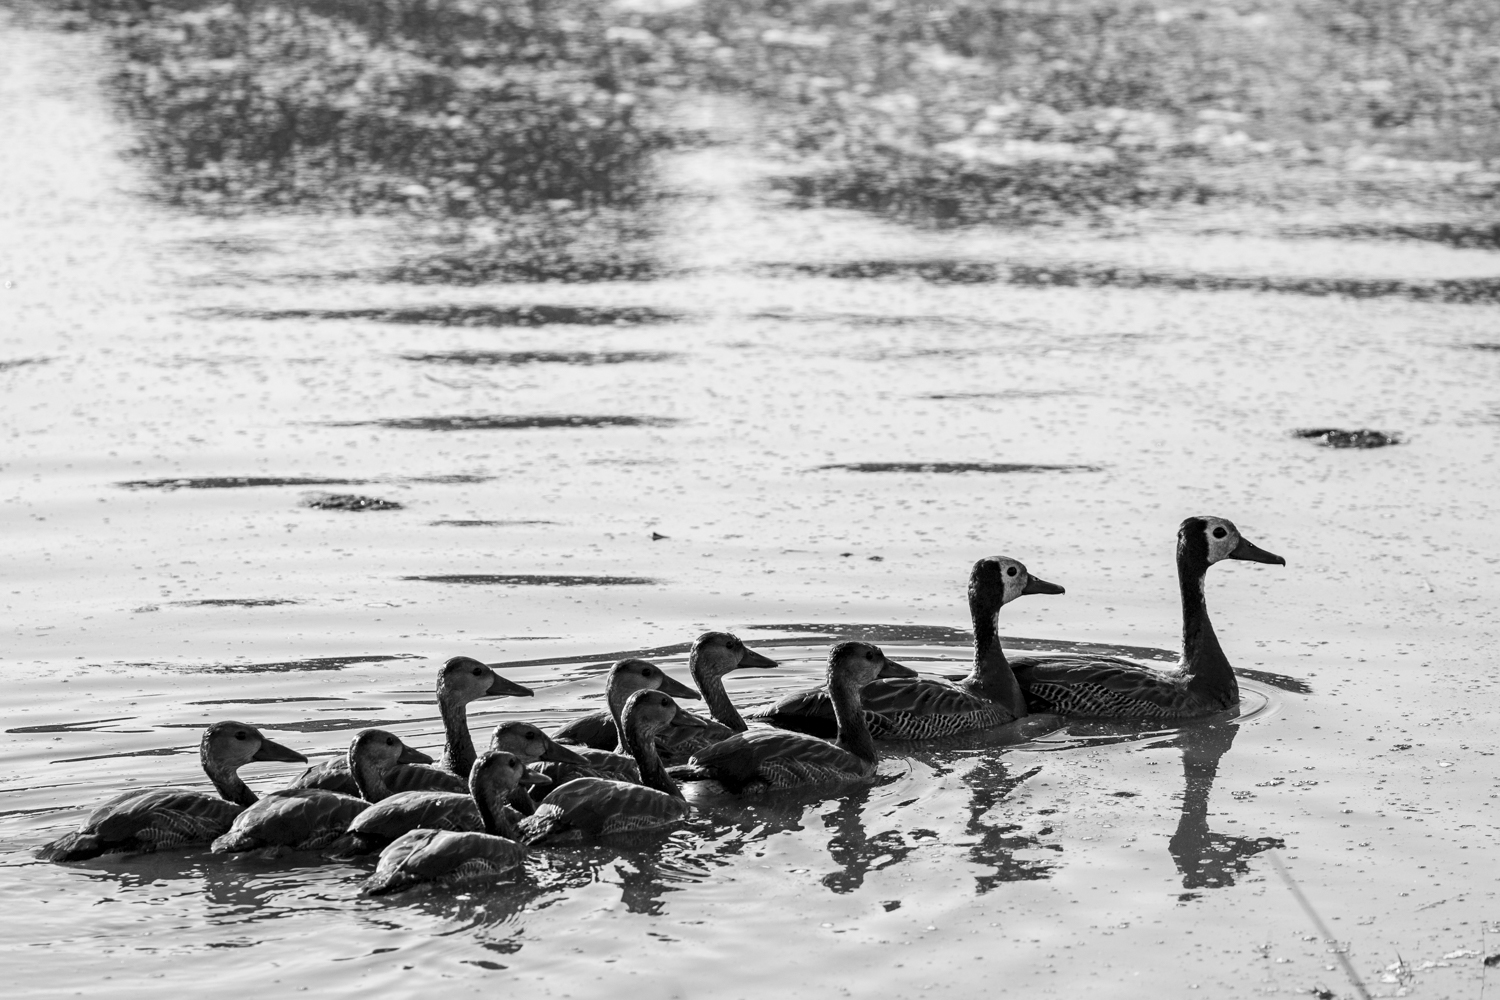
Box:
[287,657,536,796]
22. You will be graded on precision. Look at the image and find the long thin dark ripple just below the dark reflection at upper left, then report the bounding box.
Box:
[204,306,683,327]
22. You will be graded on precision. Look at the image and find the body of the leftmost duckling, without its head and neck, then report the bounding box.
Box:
[38,789,243,861]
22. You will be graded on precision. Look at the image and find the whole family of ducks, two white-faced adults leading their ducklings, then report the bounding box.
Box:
[39,517,1286,895]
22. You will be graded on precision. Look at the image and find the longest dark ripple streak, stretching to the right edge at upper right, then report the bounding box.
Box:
[764,261,1500,304]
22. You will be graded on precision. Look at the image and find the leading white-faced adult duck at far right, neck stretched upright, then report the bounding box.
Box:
[1013,514,1287,718]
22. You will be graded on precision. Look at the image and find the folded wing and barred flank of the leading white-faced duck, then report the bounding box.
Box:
[1011,657,1194,718]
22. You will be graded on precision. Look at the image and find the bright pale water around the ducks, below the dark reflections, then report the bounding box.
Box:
[0,9,1500,997]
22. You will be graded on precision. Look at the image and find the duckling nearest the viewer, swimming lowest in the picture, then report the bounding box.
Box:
[362,751,527,897]
